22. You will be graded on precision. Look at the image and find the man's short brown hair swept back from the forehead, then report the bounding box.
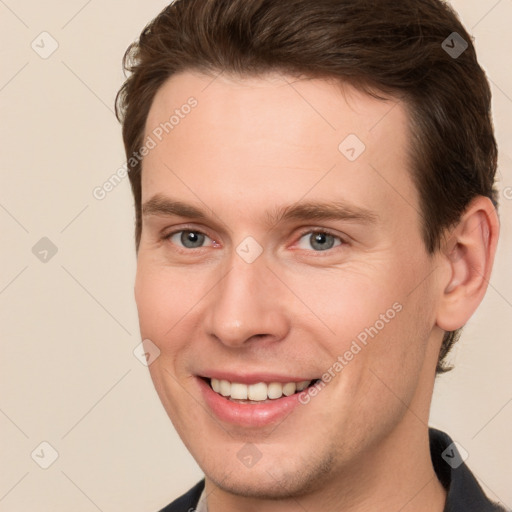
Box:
[116,0,497,373]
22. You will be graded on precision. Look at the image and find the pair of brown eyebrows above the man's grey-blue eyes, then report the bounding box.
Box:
[142,194,379,227]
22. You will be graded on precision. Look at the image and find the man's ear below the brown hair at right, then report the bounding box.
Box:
[436,196,499,331]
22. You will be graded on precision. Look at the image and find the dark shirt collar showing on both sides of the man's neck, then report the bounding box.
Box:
[160,428,506,512]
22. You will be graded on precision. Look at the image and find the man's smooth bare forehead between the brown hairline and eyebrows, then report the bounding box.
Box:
[142,72,418,229]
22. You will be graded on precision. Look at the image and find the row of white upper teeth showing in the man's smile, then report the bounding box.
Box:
[211,379,311,402]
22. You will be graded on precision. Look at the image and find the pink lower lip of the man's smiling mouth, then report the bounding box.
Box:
[197,377,300,427]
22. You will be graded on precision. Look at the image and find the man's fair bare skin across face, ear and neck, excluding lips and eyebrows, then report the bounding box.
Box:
[135,72,498,512]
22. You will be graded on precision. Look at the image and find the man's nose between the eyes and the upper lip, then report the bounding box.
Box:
[204,254,290,348]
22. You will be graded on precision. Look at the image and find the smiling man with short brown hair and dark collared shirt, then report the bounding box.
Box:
[118,0,508,512]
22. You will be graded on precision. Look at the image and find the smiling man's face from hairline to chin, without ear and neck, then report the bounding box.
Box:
[135,72,441,496]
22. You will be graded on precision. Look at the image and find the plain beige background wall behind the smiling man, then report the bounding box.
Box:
[0,0,512,512]
